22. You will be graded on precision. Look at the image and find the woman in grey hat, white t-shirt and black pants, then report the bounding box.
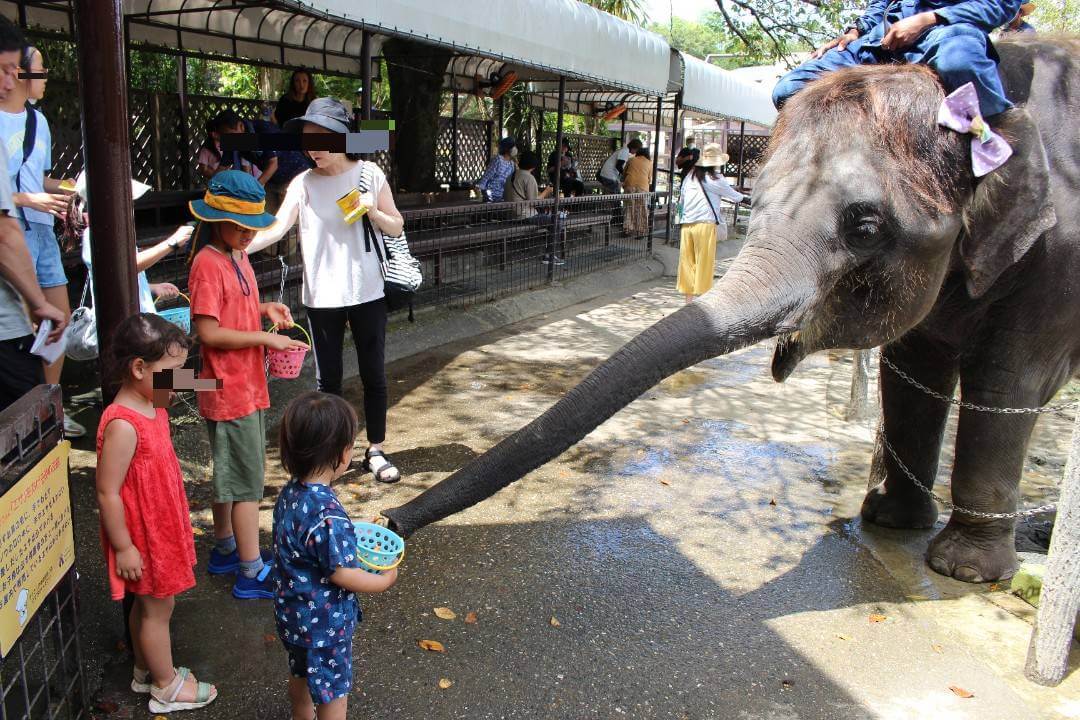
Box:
[247,97,405,483]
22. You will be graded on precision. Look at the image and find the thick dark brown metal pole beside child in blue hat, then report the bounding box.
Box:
[75,0,138,405]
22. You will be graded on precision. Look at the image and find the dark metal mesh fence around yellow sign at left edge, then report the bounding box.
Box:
[0,385,90,720]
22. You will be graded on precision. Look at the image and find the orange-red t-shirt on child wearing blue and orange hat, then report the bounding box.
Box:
[188,245,270,420]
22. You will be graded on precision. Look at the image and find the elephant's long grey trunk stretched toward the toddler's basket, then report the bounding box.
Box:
[382,257,798,536]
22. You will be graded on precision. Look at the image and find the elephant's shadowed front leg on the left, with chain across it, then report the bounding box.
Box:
[862,332,958,528]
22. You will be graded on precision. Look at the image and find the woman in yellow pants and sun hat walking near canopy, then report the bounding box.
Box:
[676,144,746,302]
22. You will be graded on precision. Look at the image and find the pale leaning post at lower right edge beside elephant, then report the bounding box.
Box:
[1024,409,1080,685]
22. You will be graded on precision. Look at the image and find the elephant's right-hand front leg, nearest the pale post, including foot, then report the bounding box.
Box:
[927,381,1042,583]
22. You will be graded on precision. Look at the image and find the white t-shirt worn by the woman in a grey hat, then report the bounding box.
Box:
[278,161,387,308]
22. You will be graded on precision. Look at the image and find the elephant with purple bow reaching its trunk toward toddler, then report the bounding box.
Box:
[381,35,1080,583]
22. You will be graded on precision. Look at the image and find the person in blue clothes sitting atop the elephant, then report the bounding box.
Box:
[772,0,1021,120]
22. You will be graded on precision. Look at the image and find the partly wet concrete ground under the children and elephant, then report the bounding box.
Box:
[72,249,1080,720]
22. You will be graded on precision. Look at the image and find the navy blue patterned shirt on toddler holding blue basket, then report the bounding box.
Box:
[273,479,362,648]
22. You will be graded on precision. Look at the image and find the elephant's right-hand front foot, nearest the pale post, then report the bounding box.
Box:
[927,517,1018,583]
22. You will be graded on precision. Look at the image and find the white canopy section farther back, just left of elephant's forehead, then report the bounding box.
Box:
[679,53,777,127]
